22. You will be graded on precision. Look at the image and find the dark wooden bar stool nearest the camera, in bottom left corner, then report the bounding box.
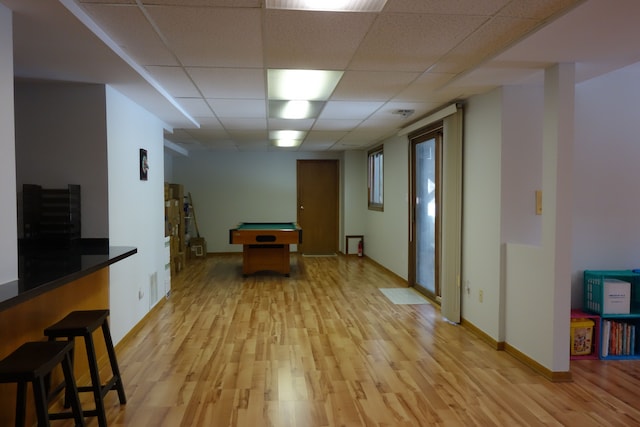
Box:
[0,341,85,427]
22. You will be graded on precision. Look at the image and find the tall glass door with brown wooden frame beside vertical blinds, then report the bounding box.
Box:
[409,124,442,302]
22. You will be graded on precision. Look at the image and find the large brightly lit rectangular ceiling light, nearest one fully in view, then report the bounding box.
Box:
[267,69,343,101]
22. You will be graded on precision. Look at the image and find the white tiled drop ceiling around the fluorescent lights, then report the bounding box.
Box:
[0,0,640,152]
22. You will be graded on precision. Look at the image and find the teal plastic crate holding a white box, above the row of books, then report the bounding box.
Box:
[583,270,640,316]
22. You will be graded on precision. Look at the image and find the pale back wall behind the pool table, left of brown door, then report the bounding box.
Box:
[173,151,342,253]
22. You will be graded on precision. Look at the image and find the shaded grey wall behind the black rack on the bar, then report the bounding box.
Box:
[15,82,109,238]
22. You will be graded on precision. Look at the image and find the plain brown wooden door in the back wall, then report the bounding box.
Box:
[297,160,338,255]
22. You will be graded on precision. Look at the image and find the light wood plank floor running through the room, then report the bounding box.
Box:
[54,255,640,427]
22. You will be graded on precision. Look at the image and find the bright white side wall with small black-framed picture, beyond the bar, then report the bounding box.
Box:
[106,86,165,342]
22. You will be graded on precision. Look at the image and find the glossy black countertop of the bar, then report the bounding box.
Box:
[0,239,138,310]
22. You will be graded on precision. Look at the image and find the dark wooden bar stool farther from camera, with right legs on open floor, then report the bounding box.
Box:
[44,310,127,427]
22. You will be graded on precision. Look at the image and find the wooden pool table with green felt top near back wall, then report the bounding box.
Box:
[229,222,302,277]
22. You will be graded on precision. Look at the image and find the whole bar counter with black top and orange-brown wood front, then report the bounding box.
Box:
[0,239,138,426]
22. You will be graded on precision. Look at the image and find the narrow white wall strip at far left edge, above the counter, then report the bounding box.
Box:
[0,5,18,284]
